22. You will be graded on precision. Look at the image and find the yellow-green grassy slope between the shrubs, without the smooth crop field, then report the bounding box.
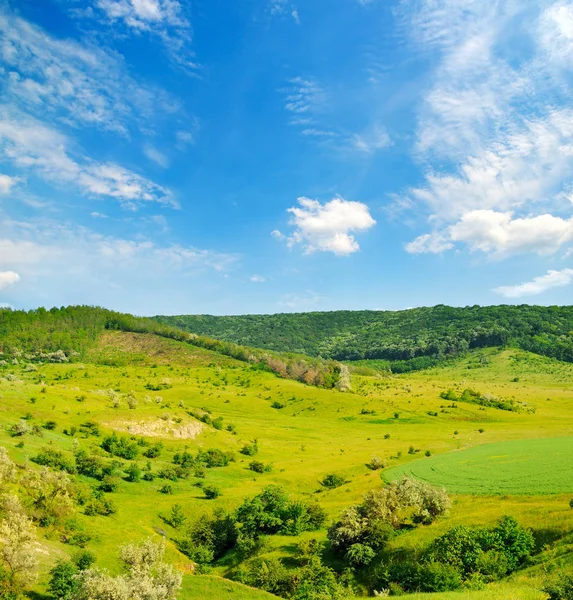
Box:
[0,332,573,600]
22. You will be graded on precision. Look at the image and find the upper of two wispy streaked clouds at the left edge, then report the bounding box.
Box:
[0,12,184,135]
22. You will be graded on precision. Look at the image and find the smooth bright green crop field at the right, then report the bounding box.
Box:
[385,437,573,495]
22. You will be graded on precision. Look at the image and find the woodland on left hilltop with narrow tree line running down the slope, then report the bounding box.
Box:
[0,306,340,388]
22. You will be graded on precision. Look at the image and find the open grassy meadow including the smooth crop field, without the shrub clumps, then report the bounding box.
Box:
[0,332,573,600]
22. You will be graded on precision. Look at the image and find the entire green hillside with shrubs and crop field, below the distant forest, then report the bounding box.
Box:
[0,307,573,600]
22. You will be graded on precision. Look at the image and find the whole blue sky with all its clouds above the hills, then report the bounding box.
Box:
[0,0,573,314]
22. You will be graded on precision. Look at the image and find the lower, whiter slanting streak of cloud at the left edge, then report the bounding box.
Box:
[0,110,177,207]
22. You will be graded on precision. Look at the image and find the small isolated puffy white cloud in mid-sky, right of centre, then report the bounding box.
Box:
[272,197,376,256]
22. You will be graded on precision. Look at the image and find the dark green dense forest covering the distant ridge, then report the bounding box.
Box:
[156,305,573,370]
